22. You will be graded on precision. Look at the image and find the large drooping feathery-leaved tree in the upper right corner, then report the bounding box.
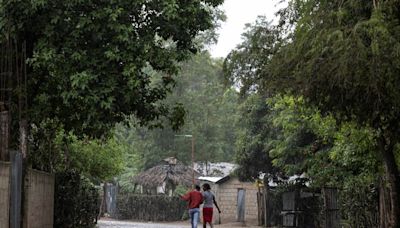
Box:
[269,0,400,227]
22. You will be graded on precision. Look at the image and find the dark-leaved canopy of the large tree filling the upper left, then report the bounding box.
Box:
[0,0,223,136]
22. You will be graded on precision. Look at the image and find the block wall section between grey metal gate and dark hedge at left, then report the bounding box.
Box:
[24,170,55,228]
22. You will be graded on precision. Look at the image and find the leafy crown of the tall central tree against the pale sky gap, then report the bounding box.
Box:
[224,17,282,97]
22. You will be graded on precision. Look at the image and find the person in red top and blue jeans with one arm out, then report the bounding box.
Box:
[181,185,203,228]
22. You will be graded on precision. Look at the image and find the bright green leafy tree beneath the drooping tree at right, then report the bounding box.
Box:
[266,95,382,227]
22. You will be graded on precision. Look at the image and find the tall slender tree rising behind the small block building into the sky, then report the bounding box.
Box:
[223,17,283,179]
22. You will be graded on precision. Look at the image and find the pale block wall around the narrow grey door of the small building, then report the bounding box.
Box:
[214,178,258,224]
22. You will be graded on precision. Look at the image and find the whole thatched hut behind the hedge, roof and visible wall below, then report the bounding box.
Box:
[133,157,200,196]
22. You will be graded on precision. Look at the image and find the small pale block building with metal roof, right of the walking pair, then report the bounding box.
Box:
[199,176,258,225]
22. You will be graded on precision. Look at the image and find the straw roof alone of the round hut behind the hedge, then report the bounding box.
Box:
[133,158,200,188]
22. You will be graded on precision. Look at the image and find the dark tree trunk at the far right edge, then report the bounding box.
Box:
[380,140,400,228]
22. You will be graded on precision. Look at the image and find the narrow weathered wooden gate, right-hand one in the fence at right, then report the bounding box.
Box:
[322,188,340,228]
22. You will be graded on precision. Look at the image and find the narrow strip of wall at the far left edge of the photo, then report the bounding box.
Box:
[0,161,10,227]
